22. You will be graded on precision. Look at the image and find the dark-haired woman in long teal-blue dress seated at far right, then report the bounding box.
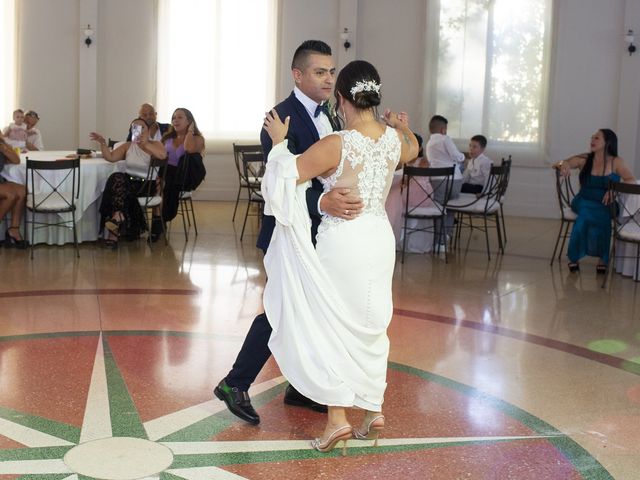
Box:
[554,128,635,273]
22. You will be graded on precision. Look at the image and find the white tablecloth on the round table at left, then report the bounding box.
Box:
[0,151,125,245]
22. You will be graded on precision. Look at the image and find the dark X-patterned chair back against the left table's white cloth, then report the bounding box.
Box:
[26,157,80,213]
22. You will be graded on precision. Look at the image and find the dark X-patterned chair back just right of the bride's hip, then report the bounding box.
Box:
[403,165,456,218]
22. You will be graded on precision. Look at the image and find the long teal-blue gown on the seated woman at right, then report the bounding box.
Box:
[567,173,620,263]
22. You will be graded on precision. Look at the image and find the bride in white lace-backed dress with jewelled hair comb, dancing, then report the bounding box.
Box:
[262,61,418,453]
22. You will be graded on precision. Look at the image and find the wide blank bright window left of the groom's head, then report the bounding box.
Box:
[156,0,277,140]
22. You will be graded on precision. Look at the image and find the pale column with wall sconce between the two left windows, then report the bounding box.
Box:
[77,0,100,148]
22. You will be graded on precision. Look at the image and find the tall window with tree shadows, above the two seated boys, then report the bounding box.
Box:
[430,0,551,164]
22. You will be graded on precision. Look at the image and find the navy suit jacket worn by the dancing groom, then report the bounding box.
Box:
[257,92,340,251]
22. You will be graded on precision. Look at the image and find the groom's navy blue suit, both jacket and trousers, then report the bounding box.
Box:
[225,92,339,391]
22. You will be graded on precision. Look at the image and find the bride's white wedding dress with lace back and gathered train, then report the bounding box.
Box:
[262,127,400,411]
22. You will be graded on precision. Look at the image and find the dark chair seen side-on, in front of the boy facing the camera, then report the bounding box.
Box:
[447,165,508,260]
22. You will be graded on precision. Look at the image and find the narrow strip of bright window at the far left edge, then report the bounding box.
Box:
[0,0,16,128]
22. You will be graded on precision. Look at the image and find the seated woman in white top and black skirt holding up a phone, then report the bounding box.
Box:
[90,118,167,248]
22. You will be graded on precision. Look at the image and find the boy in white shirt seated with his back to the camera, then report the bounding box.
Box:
[426,115,464,243]
